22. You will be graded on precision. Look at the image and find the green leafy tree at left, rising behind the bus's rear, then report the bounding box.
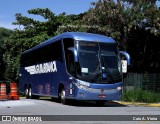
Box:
[3,8,65,80]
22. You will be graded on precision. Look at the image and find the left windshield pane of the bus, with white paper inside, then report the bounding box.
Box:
[78,41,100,81]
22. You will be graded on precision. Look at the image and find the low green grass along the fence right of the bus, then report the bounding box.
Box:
[123,88,160,103]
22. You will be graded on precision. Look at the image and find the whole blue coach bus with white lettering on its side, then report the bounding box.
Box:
[19,32,130,105]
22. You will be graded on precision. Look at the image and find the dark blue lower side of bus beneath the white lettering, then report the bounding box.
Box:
[20,61,68,96]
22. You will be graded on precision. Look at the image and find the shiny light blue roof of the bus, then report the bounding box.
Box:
[24,32,116,53]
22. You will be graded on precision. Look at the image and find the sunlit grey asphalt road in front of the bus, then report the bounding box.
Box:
[0,98,160,124]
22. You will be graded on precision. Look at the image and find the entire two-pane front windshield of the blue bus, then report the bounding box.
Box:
[77,41,121,83]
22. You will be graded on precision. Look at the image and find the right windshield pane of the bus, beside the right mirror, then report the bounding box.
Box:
[100,43,122,83]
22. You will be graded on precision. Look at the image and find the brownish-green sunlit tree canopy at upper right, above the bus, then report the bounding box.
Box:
[83,0,160,50]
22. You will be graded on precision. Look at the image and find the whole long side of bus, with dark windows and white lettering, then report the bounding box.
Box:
[19,41,68,97]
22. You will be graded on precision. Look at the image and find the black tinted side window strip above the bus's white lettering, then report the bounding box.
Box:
[21,41,62,66]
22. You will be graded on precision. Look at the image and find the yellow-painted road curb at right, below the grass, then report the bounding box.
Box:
[116,101,160,107]
